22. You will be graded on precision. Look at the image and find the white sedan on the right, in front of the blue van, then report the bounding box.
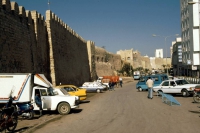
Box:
[153,79,198,97]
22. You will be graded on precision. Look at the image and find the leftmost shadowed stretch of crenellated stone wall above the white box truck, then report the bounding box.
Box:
[0,0,40,73]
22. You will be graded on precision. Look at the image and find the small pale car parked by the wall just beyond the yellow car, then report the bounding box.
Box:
[79,82,106,93]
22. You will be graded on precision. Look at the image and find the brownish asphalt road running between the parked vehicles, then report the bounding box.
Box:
[26,82,200,133]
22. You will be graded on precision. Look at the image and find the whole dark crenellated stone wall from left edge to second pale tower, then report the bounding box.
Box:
[0,0,91,85]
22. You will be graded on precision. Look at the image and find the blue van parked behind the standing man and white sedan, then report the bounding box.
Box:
[136,74,169,91]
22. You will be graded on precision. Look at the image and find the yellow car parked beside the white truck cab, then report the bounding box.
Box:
[55,85,87,101]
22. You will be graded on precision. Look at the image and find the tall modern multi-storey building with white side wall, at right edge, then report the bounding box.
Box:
[180,0,200,77]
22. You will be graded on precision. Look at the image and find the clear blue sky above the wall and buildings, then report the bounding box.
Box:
[11,0,181,57]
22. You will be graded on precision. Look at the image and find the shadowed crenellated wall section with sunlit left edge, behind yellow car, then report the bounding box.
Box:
[46,10,90,85]
